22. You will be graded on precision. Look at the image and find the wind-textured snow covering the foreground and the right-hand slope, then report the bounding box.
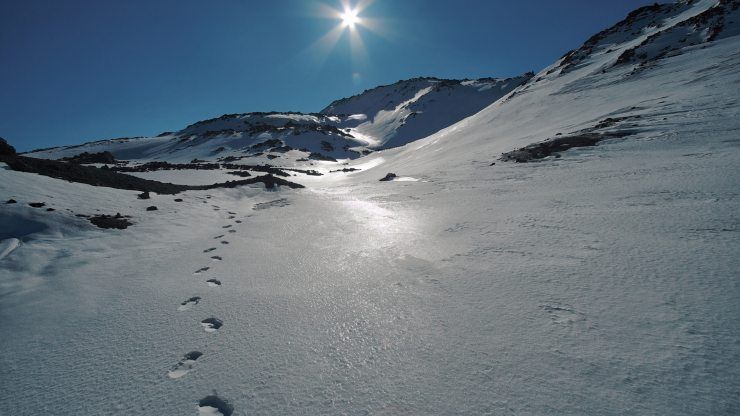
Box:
[0,1,740,415]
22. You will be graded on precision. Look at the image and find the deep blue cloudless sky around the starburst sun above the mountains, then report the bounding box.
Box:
[0,0,652,150]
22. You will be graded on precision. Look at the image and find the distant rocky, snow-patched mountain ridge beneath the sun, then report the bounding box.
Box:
[27,74,531,165]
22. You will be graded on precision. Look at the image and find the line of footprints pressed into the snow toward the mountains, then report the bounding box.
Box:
[173,200,242,416]
